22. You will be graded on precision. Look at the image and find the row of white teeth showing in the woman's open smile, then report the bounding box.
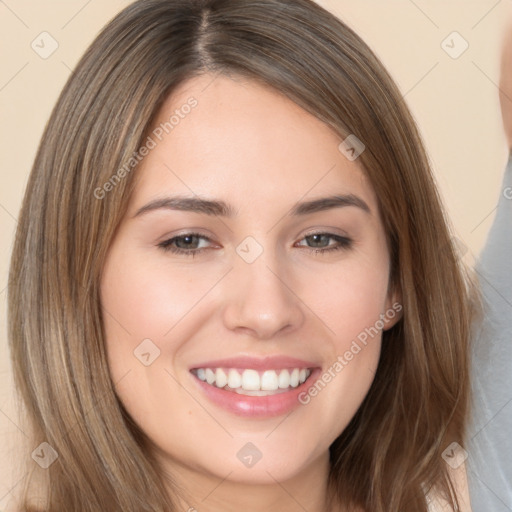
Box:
[191,368,312,396]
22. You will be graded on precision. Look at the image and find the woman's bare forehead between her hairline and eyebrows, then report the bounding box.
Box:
[128,74,376,213]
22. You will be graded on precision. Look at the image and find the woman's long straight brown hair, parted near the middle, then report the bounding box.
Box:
[8,0,471,512]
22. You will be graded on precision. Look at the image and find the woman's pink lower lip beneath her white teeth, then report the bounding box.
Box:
[193,368,320,418]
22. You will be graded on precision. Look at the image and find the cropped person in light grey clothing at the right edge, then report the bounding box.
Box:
[467,21,512,512]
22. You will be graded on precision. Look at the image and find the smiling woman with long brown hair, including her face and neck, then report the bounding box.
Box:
[9,0,471,512]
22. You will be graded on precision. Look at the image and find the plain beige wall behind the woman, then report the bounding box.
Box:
[0,0,512,511]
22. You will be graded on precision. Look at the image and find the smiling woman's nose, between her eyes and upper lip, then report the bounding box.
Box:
[223,251,304,340]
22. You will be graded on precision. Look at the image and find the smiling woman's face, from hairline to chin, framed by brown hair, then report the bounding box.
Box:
[101,75,398,483]
